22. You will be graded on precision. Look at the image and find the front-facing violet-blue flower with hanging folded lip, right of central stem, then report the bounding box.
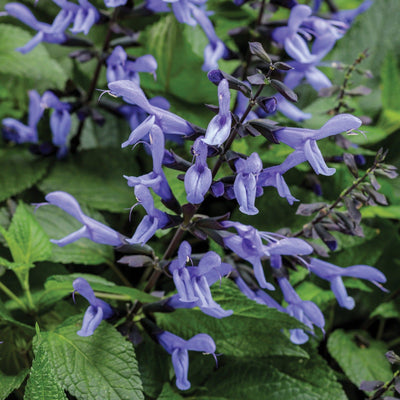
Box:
[233,153,262,215]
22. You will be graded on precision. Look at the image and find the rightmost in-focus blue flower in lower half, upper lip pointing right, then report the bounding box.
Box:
[308,258,386,310]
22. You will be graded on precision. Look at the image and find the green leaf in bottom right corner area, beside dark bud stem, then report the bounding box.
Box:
[328,329,392,387]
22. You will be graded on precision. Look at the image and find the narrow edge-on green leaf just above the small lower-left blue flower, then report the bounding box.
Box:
[42,273,159,303]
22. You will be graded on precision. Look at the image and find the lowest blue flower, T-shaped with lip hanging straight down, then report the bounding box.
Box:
[157,331,216,390]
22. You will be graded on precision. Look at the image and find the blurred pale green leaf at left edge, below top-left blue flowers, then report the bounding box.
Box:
[0,24,67,89]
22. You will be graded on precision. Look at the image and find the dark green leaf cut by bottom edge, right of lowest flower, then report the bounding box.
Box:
[204,351,347,400]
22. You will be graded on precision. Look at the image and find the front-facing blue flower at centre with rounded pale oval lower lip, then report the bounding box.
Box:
[184,137,212,204]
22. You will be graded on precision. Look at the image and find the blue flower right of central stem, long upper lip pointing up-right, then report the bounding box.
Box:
[274,114,362,176]
